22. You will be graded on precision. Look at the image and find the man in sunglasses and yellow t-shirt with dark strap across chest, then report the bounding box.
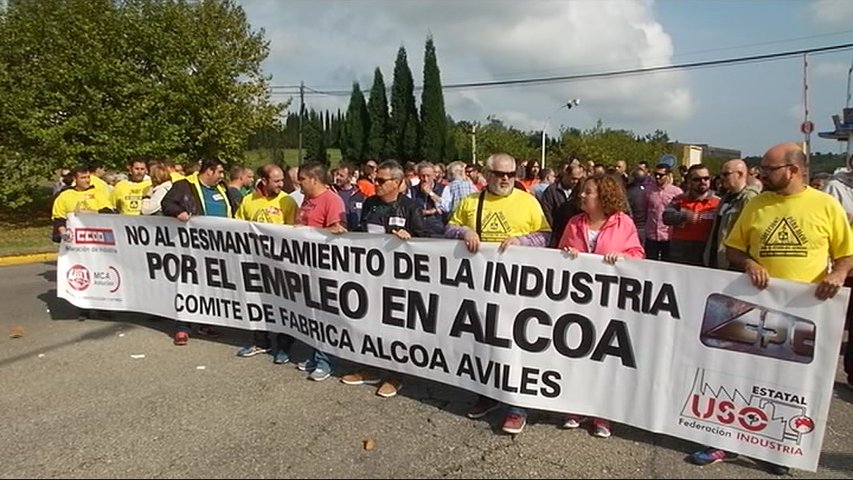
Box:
[445,153,551,434]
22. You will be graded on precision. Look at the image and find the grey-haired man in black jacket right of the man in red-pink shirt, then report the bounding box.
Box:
[341,160,422,398]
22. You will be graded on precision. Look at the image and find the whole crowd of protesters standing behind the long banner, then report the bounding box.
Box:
[53,143,853,474]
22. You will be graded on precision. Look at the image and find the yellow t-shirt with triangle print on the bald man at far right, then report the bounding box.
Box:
[726,187,853,283]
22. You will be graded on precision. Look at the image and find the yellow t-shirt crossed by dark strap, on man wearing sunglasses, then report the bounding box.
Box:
[448,188,551,243]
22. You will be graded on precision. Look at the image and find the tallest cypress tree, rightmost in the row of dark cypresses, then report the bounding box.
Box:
[419,35,447,163]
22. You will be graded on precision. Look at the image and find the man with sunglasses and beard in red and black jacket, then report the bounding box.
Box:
[663,163,720,266]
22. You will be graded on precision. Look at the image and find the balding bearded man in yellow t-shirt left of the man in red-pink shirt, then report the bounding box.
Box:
[234,163,299,365]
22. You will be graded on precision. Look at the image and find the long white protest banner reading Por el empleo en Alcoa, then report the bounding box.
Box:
[57,215,849,471]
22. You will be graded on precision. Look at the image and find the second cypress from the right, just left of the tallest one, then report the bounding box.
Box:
[391,47,418,161]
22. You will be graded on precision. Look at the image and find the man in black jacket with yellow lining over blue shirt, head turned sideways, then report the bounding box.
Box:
[160,159,241,346]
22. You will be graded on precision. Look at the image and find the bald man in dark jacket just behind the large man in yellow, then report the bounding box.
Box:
[703,158,761,270]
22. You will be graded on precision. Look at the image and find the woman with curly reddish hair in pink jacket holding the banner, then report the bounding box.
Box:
[558,175,646,438]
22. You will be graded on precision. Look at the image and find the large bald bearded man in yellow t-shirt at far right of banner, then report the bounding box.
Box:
[688,143,853,475]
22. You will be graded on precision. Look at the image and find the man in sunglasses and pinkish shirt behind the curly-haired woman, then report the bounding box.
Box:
[643,163,683,262]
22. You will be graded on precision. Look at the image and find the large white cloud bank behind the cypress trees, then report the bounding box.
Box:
[236,0,695,133]
